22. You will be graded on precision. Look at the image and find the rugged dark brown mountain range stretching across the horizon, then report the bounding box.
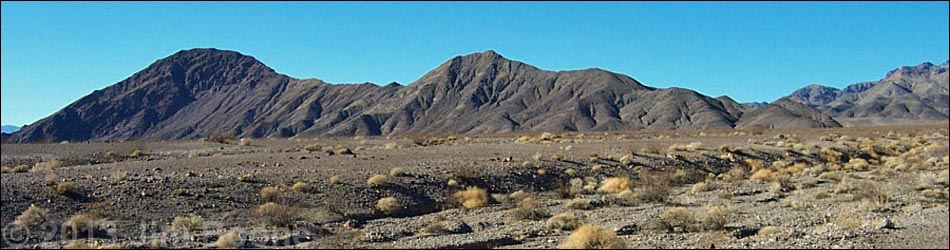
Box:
[10,49,947,143]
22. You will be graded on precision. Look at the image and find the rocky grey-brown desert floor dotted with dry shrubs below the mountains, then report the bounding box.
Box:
[0,123,950,249]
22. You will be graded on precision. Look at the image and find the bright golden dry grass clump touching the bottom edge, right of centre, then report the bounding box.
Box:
[558,224,629,249]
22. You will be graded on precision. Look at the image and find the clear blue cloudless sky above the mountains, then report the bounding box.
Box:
[0,2,950,125]
